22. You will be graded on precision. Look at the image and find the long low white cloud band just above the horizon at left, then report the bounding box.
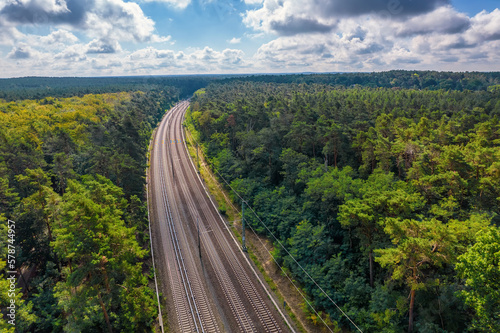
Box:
[0,40,250,76]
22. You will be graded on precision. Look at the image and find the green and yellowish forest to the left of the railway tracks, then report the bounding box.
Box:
[0,86,179,332]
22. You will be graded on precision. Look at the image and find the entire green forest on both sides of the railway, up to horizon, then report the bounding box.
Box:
[0,71,500,333]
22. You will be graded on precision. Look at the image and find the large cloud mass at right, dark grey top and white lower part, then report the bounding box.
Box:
[247,0,500,71]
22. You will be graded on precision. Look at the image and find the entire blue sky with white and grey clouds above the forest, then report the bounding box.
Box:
[0,0,500,78]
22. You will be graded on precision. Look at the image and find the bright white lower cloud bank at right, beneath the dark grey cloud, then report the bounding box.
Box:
[250,6,500,71]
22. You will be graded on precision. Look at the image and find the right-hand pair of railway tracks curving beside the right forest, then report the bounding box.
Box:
[170,101,287,332]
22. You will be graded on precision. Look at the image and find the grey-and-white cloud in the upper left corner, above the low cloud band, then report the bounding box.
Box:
[0,0,169,53]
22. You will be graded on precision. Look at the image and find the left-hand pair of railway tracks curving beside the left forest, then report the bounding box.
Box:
[149,102,220,332]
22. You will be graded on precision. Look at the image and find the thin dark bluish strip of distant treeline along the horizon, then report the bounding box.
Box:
[0,70,500,101]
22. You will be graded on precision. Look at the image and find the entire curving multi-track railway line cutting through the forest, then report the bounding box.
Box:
[148,101,290,333]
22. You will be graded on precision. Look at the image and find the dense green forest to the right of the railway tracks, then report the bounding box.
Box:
[187,79,500,333]
